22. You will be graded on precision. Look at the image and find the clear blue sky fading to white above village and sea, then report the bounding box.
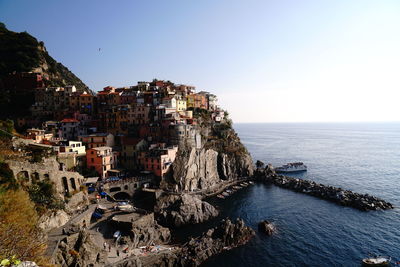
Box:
[0,0,400,123]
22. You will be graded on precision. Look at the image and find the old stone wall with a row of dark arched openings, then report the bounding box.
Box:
[7,157,84,197]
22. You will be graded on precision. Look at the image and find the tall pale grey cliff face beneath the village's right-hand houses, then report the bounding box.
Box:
[164,123,253,194]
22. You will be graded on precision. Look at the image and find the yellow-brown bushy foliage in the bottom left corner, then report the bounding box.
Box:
[0,187,48,266]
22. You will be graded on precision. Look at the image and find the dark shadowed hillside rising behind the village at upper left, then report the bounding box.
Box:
[0,23,89,117]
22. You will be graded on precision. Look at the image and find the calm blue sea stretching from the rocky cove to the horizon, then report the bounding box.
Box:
[177,123,400,267]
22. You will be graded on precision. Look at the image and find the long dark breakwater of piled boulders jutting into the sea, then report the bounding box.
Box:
[257,172,393,211]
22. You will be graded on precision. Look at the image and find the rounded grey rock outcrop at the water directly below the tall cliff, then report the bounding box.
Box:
[155,194,218,227]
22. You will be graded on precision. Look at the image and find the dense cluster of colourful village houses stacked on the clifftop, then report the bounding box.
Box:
[17,77,225,185]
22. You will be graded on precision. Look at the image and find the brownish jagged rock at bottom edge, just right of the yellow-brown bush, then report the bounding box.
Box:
[55,231,107,267]
